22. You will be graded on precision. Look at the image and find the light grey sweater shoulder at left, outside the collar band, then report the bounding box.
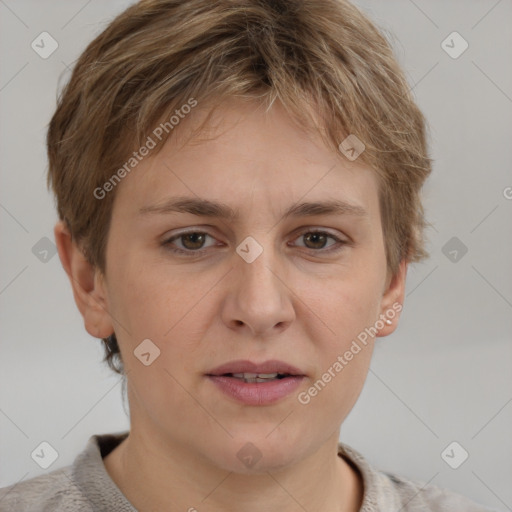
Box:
[0,466,92,512]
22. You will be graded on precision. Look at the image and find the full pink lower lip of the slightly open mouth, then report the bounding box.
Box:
[208,375,304,405]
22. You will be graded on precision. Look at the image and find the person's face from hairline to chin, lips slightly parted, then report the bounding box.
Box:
[85,102,403,471]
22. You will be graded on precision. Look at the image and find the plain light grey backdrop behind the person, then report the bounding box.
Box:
[0,0,512,510]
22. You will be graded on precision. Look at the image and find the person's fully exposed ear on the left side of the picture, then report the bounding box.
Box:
[54,221,114,338]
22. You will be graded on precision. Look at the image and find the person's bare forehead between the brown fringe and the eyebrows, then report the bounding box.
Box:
[110,97,378,223]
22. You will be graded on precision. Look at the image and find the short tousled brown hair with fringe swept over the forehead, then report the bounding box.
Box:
[47,0,431,373]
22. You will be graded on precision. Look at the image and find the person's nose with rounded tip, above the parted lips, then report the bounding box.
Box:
[222,242,295,337]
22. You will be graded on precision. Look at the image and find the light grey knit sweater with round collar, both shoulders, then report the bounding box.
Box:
[0,432,496,512]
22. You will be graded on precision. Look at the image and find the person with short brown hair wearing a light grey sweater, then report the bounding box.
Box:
[2,0,494,512]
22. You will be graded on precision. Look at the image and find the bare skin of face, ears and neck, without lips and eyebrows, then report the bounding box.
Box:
[55,101,407,512]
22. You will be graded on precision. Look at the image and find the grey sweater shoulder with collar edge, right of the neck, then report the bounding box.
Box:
[338,443,492,512]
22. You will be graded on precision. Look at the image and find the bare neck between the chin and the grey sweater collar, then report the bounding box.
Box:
[104,428,363,512]
